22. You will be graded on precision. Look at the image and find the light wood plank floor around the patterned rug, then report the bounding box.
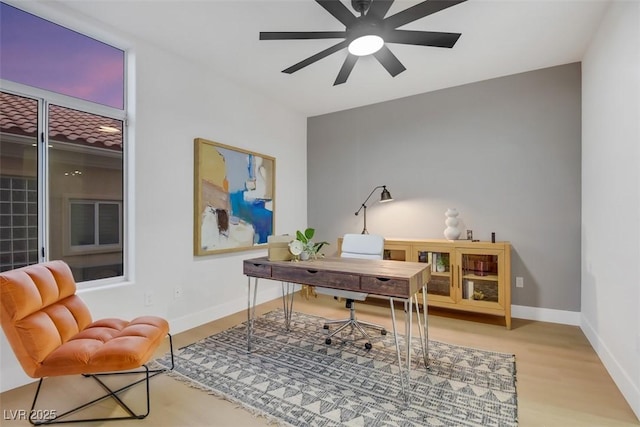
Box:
[0,295,640,427]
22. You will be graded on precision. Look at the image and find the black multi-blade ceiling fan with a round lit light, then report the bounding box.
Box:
[260,0,466,86]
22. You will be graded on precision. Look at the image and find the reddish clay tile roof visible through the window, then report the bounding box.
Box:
[0,92,122,151]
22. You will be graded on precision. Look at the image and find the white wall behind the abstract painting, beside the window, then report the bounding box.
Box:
[0,3,307,391]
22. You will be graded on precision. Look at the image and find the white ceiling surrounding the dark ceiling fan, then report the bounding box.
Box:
[47,0,609,116]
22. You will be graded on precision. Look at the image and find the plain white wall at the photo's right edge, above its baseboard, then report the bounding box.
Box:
[582,1,640,417]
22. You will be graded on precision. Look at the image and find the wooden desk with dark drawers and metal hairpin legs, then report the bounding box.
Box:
[243,257,431,401]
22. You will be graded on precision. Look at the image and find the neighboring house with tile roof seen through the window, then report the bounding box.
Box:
[0,92,123,281]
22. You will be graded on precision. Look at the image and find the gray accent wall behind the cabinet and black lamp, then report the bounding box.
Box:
[307,63,581,311]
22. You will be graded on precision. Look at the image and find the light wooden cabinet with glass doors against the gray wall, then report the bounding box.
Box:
[338,239,511,329]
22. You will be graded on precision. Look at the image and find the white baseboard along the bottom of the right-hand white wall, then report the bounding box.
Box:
[580,317,640,420]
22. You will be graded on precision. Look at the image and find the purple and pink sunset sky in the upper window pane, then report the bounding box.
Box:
[0,3,124,109]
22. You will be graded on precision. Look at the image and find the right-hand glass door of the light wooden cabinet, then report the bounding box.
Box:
[457,250,504,305]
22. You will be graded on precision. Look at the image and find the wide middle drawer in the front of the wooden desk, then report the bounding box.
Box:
[271,265,360,291]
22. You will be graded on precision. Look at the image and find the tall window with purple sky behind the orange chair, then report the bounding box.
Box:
[0,3,128,283]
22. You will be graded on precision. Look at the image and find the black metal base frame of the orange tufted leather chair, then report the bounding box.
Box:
[29,334,175,426]
